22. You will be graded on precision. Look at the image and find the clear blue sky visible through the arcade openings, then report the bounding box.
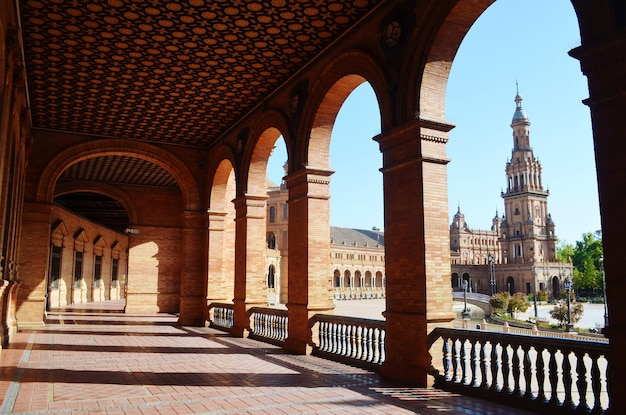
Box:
[268,0,600,243]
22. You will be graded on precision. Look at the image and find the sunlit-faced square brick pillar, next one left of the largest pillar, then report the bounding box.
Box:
[284,168,334,354]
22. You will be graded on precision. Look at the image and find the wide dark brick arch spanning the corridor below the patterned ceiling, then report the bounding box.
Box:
[36,139,203,211]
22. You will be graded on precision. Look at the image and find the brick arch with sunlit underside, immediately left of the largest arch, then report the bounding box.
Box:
[296,51,392,169]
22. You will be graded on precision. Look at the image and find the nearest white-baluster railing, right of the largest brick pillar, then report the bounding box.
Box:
[431,328,609,414]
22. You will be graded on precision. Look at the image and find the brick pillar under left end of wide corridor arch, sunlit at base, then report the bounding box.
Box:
[16,203,53,330]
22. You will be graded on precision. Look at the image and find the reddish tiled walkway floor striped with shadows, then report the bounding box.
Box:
[0,302,530,415]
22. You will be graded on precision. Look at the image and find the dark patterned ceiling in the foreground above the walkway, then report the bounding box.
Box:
[20,0,379,147]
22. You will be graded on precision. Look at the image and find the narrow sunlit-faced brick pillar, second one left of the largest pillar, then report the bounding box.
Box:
[230,195,267,337]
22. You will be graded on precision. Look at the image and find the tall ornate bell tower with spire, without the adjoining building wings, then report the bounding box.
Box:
[500,88,557,263]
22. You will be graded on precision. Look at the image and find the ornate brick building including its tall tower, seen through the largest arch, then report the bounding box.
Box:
[450,92,573,299]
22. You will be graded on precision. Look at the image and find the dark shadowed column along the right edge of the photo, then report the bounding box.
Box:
[570,31,626,414]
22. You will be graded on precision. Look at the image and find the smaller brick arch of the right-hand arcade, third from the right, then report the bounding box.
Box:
[241,111,291,195]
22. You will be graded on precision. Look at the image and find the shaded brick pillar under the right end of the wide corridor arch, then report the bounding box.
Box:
[178,212,208,327]
